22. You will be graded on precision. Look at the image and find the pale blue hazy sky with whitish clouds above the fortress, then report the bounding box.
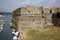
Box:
[0,0,60,12]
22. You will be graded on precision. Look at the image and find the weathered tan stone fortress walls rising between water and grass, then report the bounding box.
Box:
[13,6,60,30]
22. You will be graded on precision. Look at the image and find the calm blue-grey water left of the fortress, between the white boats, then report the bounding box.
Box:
[0,14,12,40]
